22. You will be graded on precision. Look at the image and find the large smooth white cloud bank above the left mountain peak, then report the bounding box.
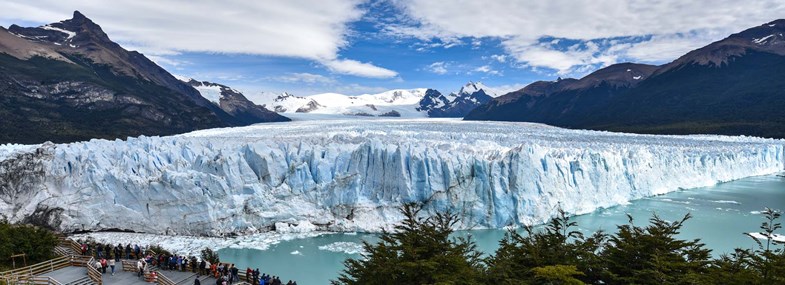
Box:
[0,0,394,77]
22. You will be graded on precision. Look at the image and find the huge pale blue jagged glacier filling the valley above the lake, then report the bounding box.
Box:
[0,119,783,236]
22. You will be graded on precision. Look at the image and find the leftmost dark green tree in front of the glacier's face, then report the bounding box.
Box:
[332,204,482,284]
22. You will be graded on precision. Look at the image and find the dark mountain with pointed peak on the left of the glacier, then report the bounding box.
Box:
[0,12,288,143]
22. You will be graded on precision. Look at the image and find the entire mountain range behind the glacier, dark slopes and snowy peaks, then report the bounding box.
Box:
[0,11,785,144]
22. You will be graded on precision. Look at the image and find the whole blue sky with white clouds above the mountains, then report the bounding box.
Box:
[0,0,785,95]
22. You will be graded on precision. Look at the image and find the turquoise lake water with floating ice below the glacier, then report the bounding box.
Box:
[219,172,785,285]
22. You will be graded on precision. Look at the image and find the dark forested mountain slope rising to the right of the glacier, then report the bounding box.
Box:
[466,20,785,138]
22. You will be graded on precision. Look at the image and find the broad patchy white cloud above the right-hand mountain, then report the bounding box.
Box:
[396,0,785,74]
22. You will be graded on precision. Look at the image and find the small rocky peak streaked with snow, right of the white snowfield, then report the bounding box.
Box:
[417,82,497,118]
